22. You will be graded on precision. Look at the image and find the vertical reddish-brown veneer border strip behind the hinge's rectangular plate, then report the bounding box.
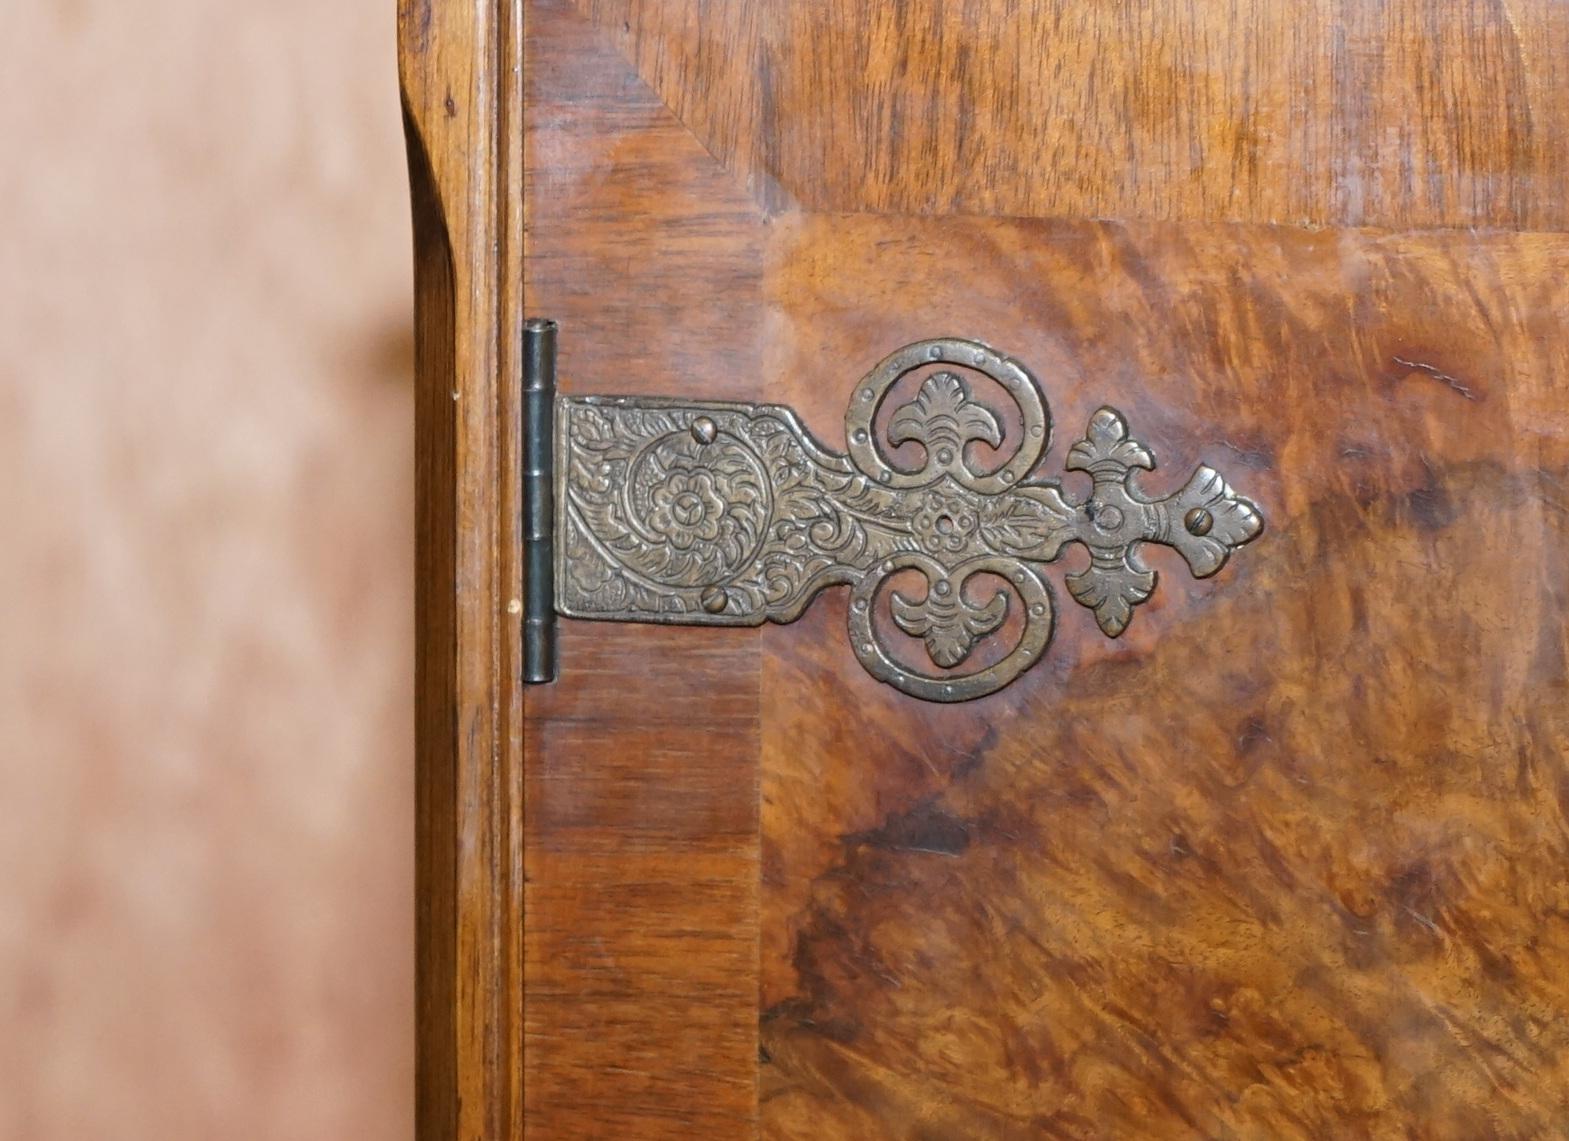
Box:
[524,3,769,1138]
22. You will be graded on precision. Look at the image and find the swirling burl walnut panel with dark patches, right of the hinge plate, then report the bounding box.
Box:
[761,217,1569,1141]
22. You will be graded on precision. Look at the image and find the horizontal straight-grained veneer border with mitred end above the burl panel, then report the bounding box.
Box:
[582,0,1569,229]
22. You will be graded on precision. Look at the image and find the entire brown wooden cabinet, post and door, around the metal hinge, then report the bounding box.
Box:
[400,0,1569,1141]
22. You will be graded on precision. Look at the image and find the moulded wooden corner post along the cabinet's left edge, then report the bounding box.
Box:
[397,0,522,1141]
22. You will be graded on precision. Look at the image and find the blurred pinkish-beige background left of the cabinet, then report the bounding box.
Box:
[0,0,413,1141]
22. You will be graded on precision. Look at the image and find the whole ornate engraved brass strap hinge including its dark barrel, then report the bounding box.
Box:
[524,320,1263,702]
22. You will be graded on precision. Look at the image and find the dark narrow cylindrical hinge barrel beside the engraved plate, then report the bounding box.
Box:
[522,319,555,684]
